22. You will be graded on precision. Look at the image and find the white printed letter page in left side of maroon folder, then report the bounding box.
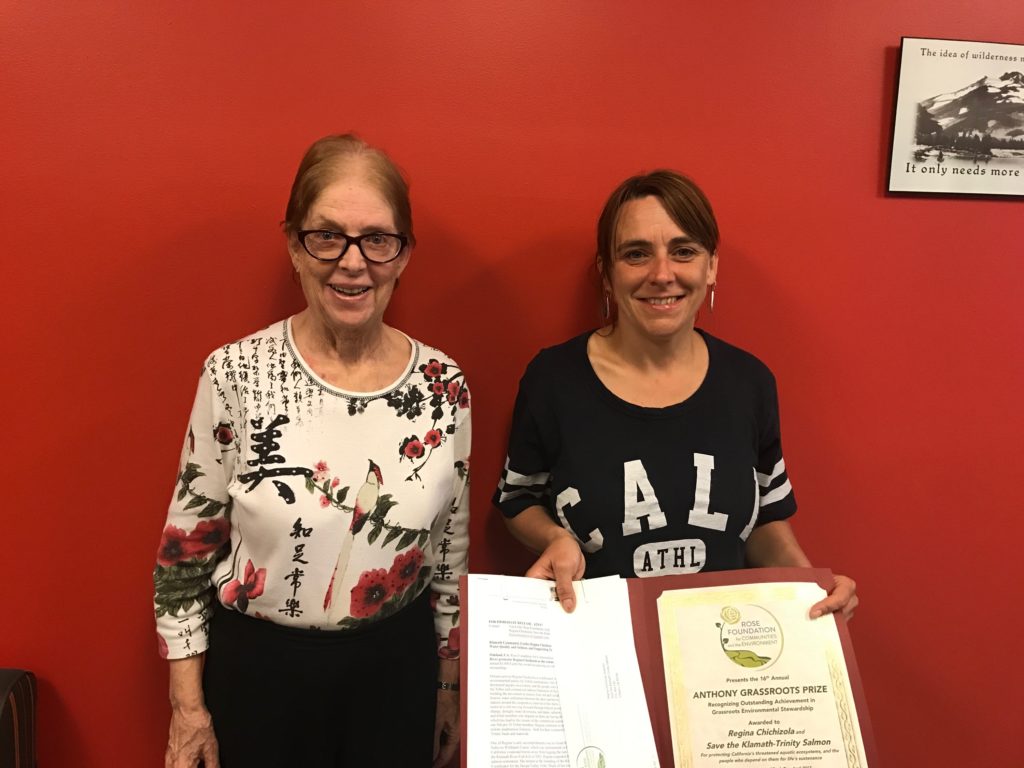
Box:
[463,575,658,768]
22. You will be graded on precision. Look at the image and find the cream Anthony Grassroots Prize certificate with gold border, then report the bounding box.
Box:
[657,574,868,768]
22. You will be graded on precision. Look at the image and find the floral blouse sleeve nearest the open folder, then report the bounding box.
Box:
[430,379,472,658]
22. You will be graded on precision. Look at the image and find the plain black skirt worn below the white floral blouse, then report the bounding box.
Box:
[203,588,437,768]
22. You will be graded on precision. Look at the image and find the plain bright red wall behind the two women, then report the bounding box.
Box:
[0,0,1024,768]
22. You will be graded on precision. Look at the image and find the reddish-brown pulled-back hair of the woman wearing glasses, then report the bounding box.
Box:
[282,133,416,245]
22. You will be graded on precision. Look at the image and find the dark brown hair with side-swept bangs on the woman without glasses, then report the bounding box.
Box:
[595,169,718,276]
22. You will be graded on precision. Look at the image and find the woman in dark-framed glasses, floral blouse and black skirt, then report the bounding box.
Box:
[154,135,470,768]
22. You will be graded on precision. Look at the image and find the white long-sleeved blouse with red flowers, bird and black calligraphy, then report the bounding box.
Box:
[154,319,470,658]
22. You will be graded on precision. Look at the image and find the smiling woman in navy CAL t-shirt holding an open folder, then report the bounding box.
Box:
[494,171,857,616]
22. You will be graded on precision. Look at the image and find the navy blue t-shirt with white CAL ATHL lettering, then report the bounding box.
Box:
[494,331,797,578]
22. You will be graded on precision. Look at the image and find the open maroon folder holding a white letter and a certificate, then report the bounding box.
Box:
[461,568,877,768]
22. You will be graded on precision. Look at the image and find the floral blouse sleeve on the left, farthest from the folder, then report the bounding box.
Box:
[153,372,238,658]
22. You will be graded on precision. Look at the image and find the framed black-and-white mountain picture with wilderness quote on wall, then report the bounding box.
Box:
[889,37,1024,196]
